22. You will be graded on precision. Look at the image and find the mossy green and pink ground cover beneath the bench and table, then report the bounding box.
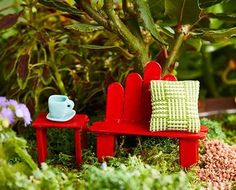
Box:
[0,115,236,189]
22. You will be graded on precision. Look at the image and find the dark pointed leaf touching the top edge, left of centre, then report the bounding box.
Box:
[39,0,83,16]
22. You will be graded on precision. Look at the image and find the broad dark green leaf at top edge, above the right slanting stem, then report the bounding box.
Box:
[165,0,200,24]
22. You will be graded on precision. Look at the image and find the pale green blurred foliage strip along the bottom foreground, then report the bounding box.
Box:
[0,153,202,190]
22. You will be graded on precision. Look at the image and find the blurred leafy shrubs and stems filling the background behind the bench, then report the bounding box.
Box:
[0,0,236,117]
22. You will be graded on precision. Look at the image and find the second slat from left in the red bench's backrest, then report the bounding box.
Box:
[122,73,143,122]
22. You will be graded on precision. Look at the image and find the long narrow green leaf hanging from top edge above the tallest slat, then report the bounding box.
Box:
[135,0,167,45]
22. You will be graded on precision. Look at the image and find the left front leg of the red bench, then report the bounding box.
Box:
[96,134,116,161]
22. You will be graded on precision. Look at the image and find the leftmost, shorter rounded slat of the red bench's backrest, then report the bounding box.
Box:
[106,82,124,121]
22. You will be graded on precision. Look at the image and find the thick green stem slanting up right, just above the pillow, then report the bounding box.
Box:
[163,32,185,73]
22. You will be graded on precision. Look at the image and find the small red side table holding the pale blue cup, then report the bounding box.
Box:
[32,113,89,166]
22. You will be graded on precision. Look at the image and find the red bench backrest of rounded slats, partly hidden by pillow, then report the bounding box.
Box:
[105,61,176,122]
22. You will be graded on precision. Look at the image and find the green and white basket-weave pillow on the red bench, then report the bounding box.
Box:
[150,80,200,133]
